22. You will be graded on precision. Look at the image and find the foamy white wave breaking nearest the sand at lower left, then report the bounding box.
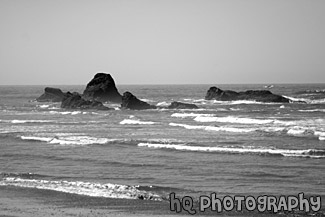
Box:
[0,177,162,201]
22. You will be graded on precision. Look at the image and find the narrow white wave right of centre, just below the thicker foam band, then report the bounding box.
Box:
[169,123,256,133]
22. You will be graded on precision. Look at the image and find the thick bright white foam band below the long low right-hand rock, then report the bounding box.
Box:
[194,116,274,124]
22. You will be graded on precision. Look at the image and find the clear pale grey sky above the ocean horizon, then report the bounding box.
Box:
[0,0,325,85]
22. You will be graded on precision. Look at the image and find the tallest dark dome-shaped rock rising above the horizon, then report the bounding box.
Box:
[83,73,122,103]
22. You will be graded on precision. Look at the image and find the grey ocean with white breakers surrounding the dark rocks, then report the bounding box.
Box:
[0,84,325,213]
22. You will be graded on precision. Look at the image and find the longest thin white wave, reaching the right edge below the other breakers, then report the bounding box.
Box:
[138,143,325,158]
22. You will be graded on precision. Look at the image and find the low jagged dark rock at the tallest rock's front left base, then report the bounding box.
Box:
[61,92,110,110]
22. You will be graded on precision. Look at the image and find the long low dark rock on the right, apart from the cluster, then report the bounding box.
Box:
[205,87,290,103]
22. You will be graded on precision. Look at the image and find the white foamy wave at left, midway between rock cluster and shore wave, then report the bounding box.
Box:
[20,135,116,145]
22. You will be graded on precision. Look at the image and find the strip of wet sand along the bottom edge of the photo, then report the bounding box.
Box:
[0,186,324,217]
